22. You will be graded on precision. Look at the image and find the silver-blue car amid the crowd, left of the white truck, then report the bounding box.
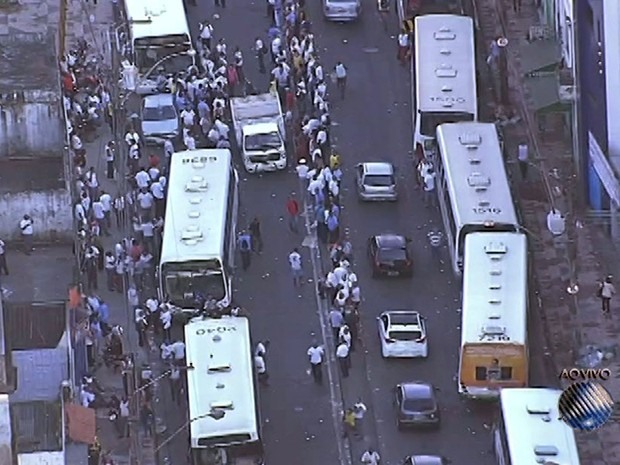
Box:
[141,94,180,145]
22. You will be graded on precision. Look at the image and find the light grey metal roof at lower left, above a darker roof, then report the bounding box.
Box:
[10,346,69,403]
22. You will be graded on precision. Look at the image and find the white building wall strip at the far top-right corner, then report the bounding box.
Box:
[602,1,620,160]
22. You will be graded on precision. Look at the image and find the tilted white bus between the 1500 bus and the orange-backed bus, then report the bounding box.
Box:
[434,122,519,275]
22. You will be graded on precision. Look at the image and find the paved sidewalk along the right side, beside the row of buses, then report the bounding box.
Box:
[476,0,620,465]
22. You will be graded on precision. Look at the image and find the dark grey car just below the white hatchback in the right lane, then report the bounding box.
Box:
[395,381,440,429]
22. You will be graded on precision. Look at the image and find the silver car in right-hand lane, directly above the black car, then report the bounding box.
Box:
[356,162,398,201]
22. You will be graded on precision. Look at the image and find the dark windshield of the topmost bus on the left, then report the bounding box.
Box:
[134,39,194,74]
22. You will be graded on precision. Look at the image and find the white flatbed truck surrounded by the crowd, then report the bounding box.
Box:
[230,92,286,173]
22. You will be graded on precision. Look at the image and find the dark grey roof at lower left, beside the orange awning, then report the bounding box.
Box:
[11,401,62,454]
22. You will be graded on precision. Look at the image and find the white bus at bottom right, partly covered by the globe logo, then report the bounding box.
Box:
[493,388,580,465]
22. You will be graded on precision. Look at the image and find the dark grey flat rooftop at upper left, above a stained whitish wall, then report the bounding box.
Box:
[0,34,60,93]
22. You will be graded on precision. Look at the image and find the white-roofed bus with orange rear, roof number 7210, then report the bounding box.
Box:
[458,232,529,399]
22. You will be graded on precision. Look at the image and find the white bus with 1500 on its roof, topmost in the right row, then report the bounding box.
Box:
[413,14,478,155]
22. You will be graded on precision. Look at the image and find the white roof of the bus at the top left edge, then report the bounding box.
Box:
[125,0,191,43]
